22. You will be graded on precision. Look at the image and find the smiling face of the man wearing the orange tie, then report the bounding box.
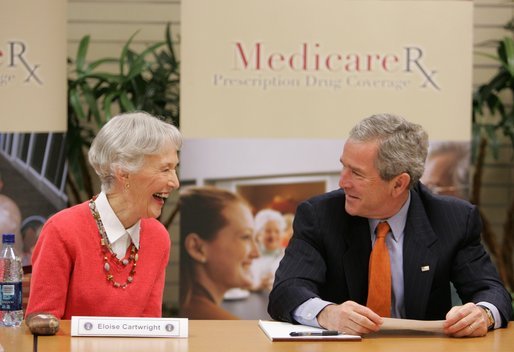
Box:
[339,139,397,219]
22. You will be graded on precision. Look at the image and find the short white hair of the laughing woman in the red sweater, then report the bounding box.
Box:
[88,111,182,192]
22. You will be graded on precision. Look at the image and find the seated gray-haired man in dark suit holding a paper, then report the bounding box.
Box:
[268,114,512,337]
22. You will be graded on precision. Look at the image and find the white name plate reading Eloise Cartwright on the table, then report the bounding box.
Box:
[71,316,189,337]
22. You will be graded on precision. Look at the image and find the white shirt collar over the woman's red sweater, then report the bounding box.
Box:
[94,192,141,249]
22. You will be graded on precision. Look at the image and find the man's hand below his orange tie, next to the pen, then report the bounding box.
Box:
[318,301,383,335]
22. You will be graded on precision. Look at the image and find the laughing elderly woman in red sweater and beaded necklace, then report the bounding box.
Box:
[26,112,182,319]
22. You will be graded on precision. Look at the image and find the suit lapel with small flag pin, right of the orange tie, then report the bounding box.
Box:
[403,192,438,319]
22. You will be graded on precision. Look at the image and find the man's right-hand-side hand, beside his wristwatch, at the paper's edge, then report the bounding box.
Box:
[443,303,488,337]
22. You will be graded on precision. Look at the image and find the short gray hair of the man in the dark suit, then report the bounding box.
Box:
[349,114,428,187]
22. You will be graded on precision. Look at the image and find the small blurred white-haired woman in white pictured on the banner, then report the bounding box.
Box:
[251,209,286,291]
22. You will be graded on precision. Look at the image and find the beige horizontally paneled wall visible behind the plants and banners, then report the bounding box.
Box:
[68,0,514,312]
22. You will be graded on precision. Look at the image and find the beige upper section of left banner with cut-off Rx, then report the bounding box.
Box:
[0,0,67,132]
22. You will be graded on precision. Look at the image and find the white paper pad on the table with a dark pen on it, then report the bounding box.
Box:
[259,320,361,341]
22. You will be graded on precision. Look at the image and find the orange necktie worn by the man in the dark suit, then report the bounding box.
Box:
[366,222,391,317]
